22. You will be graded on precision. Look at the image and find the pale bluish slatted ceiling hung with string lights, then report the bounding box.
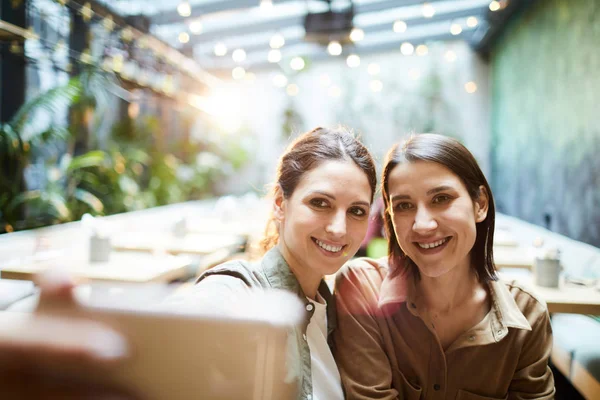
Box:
[92,0,523,74]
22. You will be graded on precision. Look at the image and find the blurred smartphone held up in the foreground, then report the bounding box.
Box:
[21,284,302,400]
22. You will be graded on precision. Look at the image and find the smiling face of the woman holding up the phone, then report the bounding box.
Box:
[275,161,372,277]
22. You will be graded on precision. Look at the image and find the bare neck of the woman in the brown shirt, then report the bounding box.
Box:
[416,263,481,313]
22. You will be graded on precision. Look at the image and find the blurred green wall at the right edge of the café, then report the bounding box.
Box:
[492,0,600,247]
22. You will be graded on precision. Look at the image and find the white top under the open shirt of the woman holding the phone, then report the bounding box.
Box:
[306,293,344,400]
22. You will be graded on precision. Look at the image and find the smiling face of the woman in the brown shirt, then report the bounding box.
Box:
[388,161,488,278]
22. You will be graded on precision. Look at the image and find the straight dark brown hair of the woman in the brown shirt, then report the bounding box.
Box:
[382,133,498,282]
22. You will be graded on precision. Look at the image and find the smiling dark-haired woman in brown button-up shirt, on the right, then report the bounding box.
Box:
[334,134,555,400]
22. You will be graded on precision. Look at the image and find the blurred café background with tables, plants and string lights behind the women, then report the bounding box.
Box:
[0,0,600,400]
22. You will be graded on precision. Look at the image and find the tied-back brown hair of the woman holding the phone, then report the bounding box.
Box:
[261,127,377,251]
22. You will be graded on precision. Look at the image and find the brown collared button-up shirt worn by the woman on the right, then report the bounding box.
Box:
[334,259,555,400]
